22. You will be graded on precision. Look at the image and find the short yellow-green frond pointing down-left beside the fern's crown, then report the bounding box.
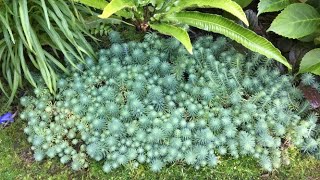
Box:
[99,0,134,18]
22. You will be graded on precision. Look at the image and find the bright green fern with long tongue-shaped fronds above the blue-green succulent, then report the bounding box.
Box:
[74,0,291,69]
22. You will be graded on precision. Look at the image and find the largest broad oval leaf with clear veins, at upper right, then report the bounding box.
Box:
[268,3,320,39]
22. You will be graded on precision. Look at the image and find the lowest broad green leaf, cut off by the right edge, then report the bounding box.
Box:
[299,48,320,75]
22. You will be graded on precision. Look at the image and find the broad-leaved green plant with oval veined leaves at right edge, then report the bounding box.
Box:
[258,0,320,75]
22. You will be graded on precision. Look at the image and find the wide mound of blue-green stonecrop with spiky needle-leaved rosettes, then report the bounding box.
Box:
[21,32,319,172]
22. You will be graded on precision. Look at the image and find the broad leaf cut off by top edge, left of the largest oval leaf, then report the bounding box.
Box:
[258,0,291,15]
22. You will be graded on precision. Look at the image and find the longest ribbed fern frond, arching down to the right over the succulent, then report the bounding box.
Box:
[167,12,291,69]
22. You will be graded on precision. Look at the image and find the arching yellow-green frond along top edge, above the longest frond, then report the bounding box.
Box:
[167,0,249,26]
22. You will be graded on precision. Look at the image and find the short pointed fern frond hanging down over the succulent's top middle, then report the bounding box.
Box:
[150,23,192,54]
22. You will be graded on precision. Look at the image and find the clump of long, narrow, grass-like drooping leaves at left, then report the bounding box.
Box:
[0,0,94,104]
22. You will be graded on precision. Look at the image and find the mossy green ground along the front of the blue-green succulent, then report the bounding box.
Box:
[0,97,320,180]
